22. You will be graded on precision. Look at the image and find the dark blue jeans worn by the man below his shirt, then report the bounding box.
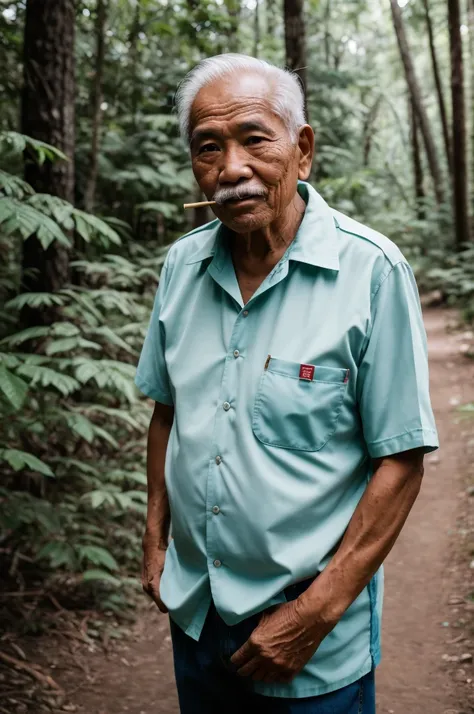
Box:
[171,581,375,714]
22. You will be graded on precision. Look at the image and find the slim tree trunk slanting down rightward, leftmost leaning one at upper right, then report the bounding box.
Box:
[390,0,444,204]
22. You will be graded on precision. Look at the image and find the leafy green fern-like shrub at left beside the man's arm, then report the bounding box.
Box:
[0,135,159,607]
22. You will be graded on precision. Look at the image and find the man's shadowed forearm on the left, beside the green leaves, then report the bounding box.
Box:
[146,404,173,550]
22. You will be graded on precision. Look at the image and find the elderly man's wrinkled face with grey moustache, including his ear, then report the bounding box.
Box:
[190,73,312,233]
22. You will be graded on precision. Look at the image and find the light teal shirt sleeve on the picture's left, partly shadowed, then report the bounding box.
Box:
[135,263,173,406]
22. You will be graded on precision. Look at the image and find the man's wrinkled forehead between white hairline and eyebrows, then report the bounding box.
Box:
[189,72,284,134]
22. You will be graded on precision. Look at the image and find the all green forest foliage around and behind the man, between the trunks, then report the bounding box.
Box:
[0,0,474,608]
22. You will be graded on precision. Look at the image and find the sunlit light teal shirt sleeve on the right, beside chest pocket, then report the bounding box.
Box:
[357,262,439,458]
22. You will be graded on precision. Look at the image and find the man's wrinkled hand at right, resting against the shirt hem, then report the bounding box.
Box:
[231,600,335,682]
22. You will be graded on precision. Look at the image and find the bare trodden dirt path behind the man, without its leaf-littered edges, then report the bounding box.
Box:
[54,310,474,714]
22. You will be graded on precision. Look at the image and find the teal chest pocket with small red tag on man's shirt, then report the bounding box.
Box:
[252,357,349,451]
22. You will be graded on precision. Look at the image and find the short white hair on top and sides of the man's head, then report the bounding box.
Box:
[176,53,305,141]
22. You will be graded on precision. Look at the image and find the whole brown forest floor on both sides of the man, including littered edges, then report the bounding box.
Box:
[0,309,474,714]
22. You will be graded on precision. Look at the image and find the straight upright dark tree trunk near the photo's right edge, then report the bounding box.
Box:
[448,0,469,249]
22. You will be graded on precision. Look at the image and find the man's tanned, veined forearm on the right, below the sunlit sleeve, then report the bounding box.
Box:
[298,450,423,630]
